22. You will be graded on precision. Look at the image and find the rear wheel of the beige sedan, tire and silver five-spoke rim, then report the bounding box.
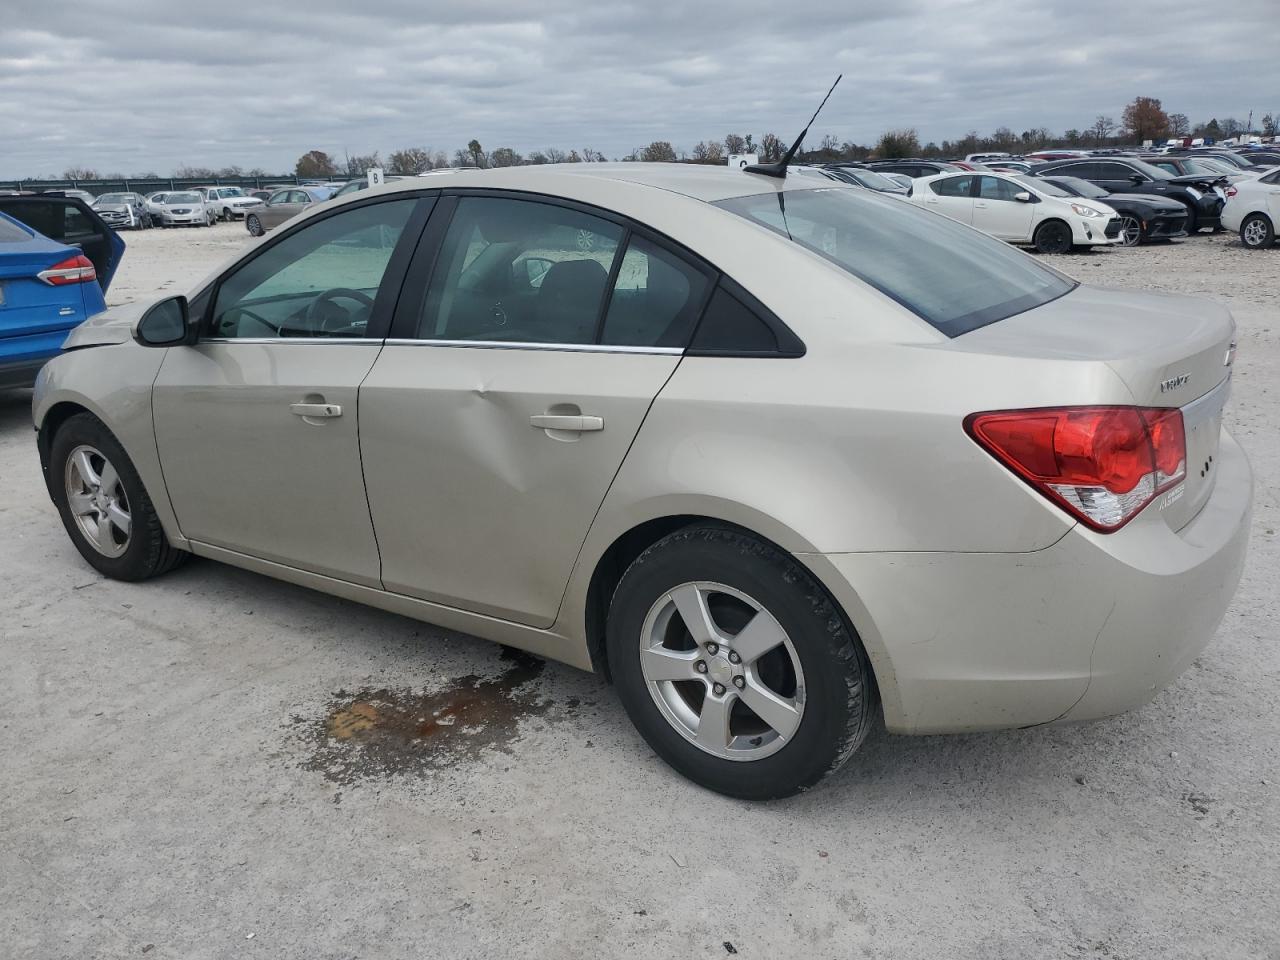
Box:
[607,526,874,800]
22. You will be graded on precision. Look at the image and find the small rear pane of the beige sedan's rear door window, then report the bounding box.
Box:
[600,237,710,347]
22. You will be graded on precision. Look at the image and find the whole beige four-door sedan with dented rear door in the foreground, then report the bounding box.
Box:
[27,164,1252,799]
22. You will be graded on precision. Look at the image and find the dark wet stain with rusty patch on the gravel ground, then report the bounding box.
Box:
[293,649,579,783]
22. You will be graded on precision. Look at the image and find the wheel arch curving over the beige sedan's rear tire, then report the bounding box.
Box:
[582,512,899,710]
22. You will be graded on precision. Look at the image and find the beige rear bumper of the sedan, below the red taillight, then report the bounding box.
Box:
[806,431,1253,733]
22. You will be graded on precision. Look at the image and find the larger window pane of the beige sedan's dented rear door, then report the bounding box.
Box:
[417,197,623,344]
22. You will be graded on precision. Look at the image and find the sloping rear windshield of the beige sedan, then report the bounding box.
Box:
[717,187,1075,337]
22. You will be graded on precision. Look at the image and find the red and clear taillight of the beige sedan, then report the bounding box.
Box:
[964,407,1187,532]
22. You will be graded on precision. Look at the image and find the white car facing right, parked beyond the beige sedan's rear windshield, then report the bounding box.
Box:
[910,172,1121,253]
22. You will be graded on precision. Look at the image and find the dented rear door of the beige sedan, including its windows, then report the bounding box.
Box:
[360,193,712,627]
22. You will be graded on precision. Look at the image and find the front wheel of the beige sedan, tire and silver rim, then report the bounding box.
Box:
[49,413,188,580]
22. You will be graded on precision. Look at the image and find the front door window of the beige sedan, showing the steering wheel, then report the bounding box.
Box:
[210,198,417,339]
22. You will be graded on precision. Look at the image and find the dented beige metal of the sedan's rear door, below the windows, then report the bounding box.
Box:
[360,343,680,627]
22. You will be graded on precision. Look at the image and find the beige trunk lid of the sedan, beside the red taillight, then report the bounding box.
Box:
[956,285,1235,530]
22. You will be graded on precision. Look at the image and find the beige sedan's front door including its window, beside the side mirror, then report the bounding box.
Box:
[152,197,430,586]
